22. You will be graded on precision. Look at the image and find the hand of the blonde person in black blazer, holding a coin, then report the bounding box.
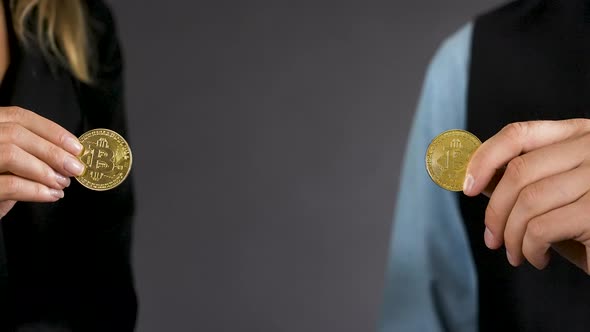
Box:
[0,107,84,218]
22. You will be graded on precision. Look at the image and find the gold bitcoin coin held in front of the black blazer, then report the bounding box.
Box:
[76,128,133,191]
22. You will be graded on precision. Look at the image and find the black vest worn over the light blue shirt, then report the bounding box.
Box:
[460,0,590,332]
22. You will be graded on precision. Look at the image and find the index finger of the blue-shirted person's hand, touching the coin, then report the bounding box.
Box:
[463,119,590,196]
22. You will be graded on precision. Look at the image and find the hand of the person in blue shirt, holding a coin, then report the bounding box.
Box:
[463,119,590,273]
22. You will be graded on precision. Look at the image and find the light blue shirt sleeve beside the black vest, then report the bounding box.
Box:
[378,23,483,332]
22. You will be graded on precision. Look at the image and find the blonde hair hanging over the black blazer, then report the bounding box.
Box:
[10,0,92,83]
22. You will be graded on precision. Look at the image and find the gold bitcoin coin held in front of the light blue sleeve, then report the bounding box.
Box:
[426,129,481,191]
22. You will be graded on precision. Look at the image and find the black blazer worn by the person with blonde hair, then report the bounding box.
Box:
[0,0,137,332]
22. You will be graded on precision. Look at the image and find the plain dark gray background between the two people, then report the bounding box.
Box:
[111,0,499,332]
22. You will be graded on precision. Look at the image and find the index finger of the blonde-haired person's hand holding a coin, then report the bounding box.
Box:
[0,107,83,156]
